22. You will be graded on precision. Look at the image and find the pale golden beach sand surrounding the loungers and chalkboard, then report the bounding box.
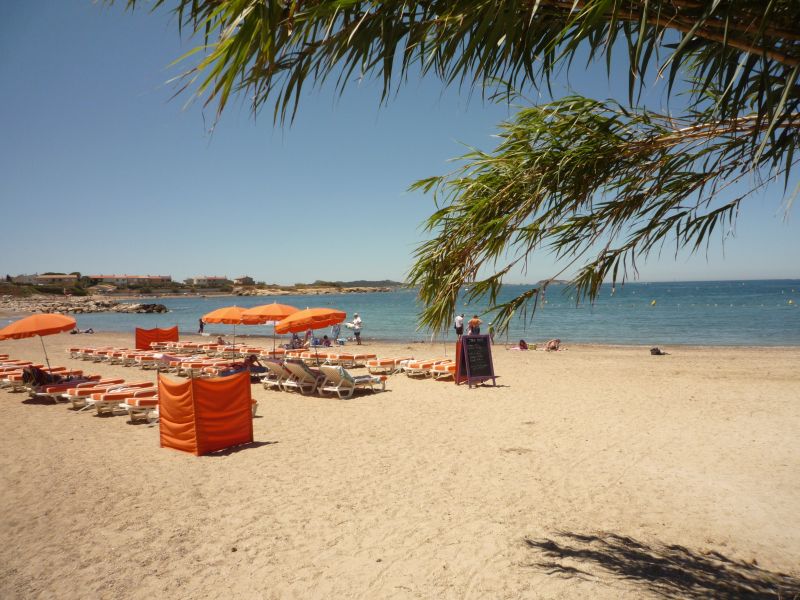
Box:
[0,334,800,599]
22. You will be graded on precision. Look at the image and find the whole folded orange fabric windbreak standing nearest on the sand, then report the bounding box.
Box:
[158,371,253,456]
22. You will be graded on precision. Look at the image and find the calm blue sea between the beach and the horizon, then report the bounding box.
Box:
[45,279,800,346]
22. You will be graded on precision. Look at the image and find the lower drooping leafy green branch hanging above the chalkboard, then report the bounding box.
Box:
[411,96,790,336]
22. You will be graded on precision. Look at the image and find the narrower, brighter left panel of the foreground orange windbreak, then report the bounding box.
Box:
[158,375,198,454]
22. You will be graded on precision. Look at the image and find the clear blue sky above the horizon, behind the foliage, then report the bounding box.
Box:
[0,0,800,283]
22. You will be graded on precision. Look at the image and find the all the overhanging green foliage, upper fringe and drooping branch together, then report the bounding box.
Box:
[106,0,800,330]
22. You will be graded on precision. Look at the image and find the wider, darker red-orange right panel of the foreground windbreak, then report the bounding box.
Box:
[192,371,253,454]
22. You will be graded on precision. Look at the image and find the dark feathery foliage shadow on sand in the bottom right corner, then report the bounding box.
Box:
[525,532,800,600]
